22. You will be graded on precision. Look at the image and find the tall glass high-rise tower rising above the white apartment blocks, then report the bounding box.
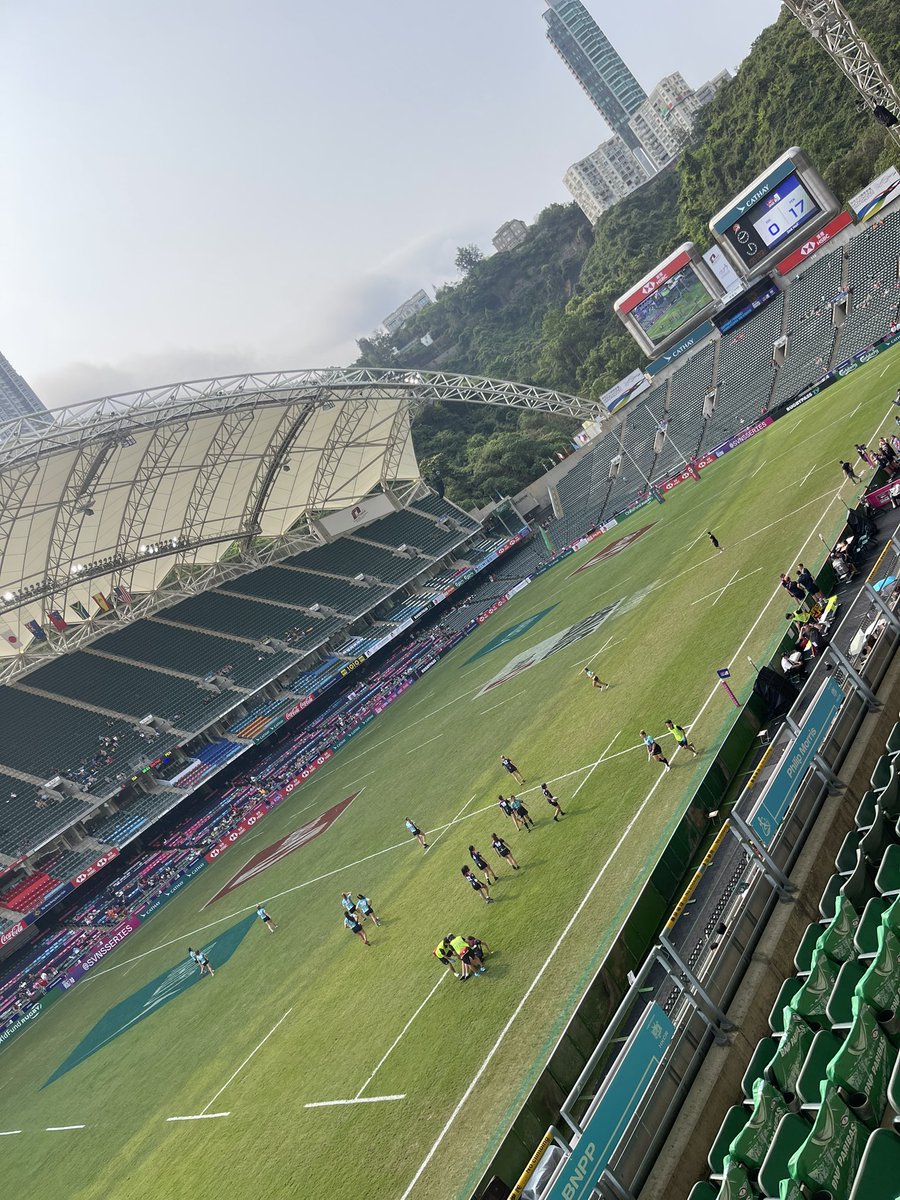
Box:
[544,0,647,150]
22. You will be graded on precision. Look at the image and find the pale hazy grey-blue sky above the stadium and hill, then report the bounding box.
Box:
[0,0,780,407]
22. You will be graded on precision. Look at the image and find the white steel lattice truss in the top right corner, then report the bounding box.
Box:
[784,0,900,145]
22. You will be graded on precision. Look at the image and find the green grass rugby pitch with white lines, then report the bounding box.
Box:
[0,350,900,1200]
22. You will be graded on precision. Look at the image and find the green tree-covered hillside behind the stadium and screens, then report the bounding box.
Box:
[359,0,900,504]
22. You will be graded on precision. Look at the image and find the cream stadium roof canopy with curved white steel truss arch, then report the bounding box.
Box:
[0,368,598,682]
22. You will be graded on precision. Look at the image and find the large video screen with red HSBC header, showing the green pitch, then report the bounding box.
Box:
[612,241,725,358]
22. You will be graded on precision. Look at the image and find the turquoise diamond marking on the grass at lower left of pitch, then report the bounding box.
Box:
[43,913,257,1087]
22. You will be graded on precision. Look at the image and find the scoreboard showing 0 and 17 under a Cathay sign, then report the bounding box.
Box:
[709,146,840,278]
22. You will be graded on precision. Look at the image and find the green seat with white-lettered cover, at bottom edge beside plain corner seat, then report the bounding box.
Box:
[787,1084,869,1200]
